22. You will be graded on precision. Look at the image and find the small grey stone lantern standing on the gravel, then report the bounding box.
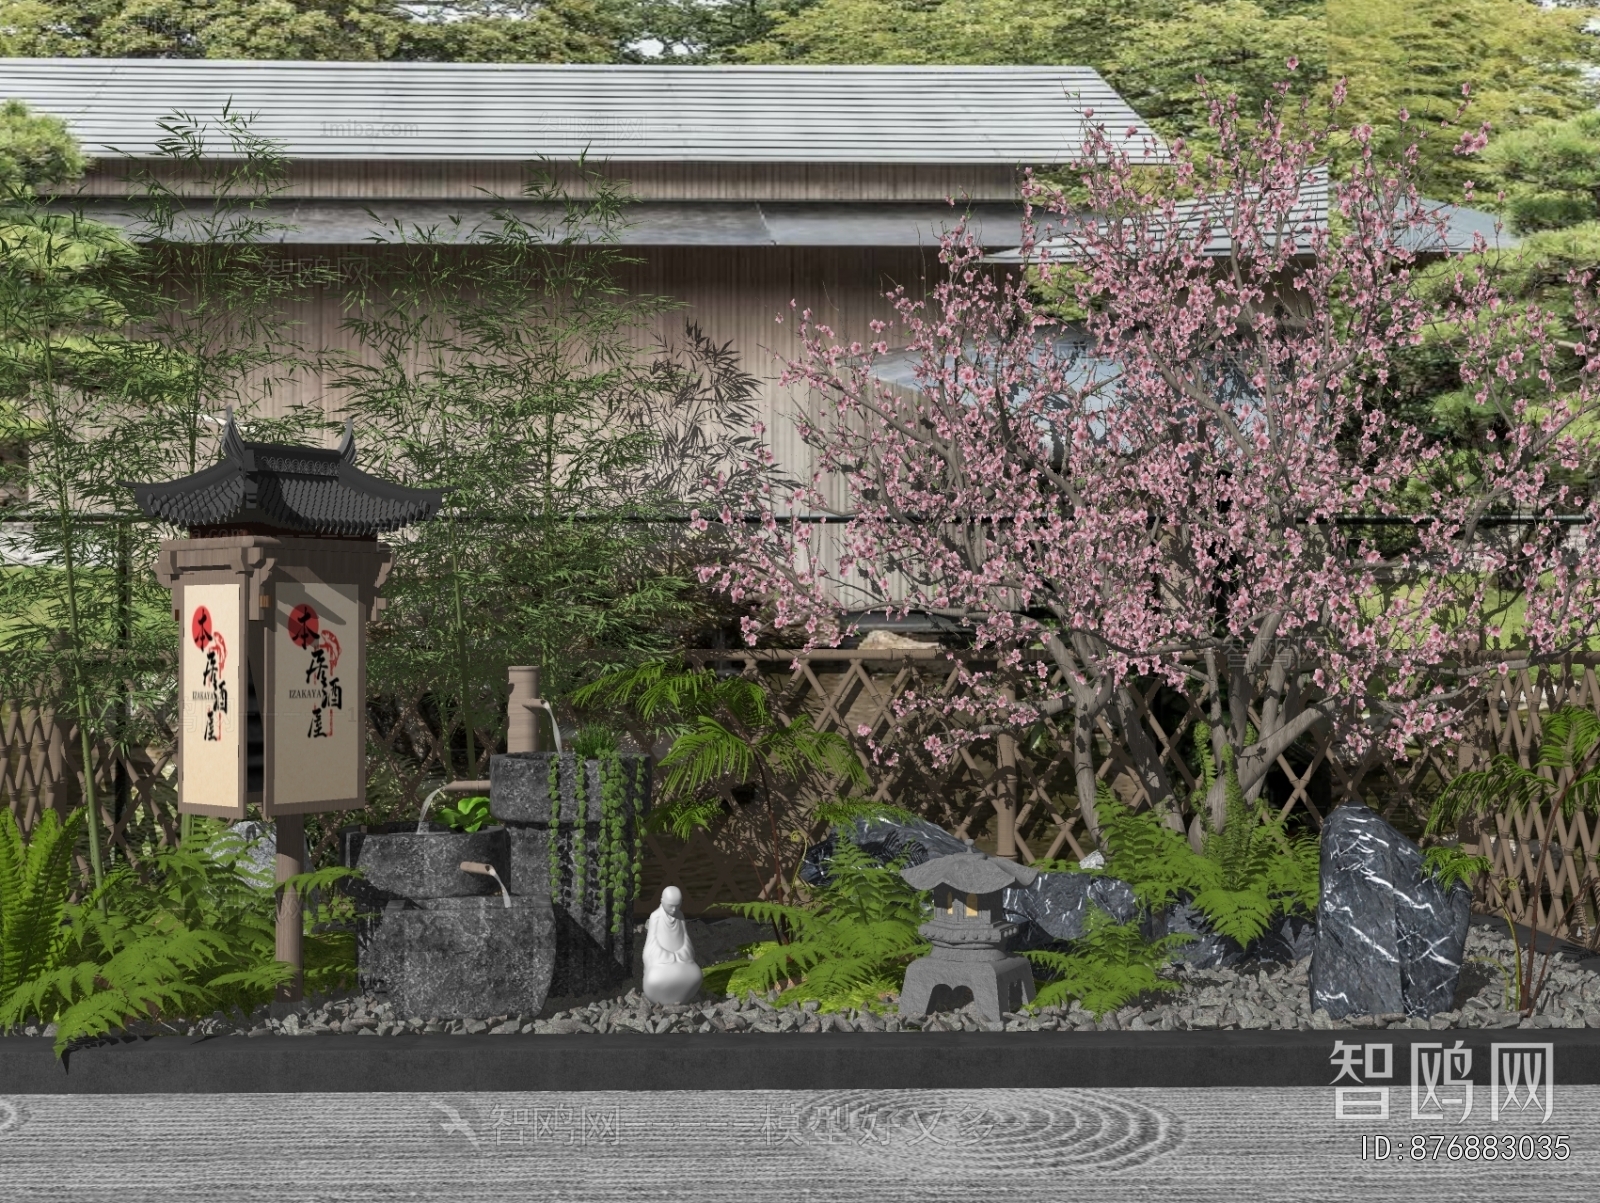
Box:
[899,841,1038,1021]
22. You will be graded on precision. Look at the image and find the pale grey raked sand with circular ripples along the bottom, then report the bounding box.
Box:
[0,1086,1600,1203]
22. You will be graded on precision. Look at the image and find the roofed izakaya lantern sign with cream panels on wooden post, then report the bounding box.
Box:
[130,410,443,998]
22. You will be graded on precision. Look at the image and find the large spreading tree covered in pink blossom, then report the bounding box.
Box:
[702,82,1600,838]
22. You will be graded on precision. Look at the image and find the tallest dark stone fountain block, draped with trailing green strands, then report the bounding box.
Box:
[490,752,650,998]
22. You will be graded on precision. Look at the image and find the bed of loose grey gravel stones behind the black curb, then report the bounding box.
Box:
[12,925,1600,1037]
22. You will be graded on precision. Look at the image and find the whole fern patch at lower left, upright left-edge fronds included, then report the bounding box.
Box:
[0,811,355,1054]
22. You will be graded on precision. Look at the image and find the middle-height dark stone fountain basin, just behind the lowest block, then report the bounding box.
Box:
[344,827,510,907]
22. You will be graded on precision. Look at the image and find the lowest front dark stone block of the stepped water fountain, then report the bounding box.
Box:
[357,893,557,1019]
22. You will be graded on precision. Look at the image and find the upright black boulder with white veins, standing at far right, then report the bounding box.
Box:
[1310,805,1472,1019]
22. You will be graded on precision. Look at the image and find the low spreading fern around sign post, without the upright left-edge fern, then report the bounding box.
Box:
[0,827,355,1053]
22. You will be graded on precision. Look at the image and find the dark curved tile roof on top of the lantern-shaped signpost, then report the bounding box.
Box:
[131,410,445,539]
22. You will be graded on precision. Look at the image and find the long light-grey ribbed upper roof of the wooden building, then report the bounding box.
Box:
[0,59,1165,165]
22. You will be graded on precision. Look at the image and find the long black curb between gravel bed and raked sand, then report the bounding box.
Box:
[0,1029,1600,1094]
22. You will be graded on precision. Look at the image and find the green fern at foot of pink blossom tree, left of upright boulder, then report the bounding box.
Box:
[1099,757,1318,947]
